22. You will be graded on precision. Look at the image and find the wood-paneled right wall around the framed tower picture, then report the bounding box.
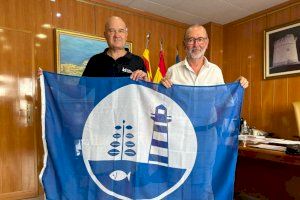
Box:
[223,1,300,139]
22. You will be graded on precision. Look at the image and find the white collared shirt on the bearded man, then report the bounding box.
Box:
[166,57,224,86]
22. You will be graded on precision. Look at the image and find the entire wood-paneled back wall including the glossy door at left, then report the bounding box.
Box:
[0,0,187,199]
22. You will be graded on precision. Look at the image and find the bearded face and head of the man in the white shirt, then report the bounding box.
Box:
[184,27,208,59]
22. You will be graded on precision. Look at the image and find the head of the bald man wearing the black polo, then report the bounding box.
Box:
[104,19,128,49]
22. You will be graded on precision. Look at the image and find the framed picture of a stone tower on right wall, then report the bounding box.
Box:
[264,21,300,79]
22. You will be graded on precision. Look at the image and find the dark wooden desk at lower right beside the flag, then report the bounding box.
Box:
[235,147,300,200]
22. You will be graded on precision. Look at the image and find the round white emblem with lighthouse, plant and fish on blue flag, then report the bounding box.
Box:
[82,84,197,199]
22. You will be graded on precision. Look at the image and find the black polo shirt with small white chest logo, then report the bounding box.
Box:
[82,48,146,77]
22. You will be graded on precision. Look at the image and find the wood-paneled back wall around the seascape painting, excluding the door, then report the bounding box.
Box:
[35,0,187,71]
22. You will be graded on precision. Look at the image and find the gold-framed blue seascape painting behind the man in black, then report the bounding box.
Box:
[55,29,132,76]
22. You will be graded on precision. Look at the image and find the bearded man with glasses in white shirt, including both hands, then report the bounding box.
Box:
[161,24,248,88]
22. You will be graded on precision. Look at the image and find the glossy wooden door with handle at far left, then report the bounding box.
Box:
[0,28,37,199]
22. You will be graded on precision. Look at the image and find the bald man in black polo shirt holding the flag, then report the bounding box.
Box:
[82,16,148,81]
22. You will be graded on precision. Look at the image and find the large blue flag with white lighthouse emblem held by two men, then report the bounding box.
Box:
[40,72,244,200]
